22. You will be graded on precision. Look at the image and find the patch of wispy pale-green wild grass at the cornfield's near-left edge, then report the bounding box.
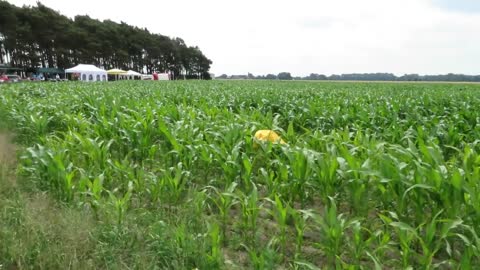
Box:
[0,131,96,270]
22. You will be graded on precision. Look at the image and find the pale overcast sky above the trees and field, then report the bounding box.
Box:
[8,0,480,75]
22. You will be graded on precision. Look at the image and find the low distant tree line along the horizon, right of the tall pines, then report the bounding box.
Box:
[217,72,480,82]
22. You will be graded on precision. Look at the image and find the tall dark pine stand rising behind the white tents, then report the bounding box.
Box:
[0,0,212,79]
